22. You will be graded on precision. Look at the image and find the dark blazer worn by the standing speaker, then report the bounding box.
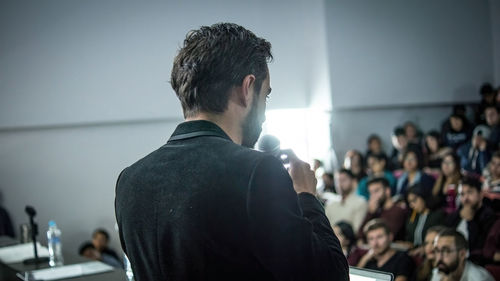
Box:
[115,121,348,281]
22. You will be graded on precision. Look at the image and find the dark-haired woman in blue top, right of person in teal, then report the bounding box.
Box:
[395,148,434,198]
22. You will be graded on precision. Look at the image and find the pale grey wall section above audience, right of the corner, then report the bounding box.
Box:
[326,0,493,108]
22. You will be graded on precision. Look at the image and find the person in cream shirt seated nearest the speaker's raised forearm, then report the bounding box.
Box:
[325,169,368,231]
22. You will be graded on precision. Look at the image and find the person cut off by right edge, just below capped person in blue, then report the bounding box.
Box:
[483,151,500,213]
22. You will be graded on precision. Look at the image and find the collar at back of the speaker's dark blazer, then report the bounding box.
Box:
[168,120,232,142]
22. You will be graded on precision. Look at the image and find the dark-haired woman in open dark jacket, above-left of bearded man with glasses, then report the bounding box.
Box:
[405,184,445,250]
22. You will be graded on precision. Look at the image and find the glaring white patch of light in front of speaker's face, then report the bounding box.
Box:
[262,109,330,162]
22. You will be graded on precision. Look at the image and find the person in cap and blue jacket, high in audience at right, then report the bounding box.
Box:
[457,125,491,175]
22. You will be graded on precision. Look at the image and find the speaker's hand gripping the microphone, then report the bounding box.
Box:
[282,149,317,195]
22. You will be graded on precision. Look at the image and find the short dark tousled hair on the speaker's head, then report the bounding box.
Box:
[170,23,272,117]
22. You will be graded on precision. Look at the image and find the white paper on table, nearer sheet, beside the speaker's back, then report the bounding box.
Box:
[31,261,113,280]
